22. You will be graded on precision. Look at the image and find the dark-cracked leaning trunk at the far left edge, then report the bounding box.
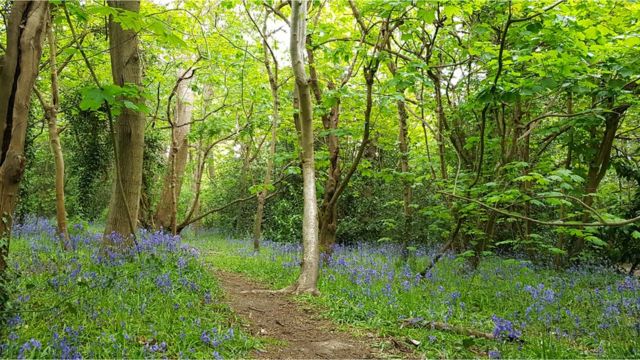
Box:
[0,1,49,312]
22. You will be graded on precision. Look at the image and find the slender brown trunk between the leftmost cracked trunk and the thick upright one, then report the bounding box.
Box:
[43,14,71,250]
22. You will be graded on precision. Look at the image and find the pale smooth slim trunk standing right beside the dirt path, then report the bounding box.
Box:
[290,0,320,294]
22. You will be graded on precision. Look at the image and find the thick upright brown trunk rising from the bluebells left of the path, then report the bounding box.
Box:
[105,0,145,246]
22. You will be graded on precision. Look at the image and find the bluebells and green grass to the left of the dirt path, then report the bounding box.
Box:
[0,219,257,359]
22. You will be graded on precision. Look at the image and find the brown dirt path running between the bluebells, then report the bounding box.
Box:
[216,271,392,359]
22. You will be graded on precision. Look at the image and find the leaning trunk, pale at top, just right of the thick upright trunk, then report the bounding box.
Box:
[154,70,193,234]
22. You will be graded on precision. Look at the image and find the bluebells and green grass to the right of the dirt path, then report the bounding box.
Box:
[196,235,640,358]
